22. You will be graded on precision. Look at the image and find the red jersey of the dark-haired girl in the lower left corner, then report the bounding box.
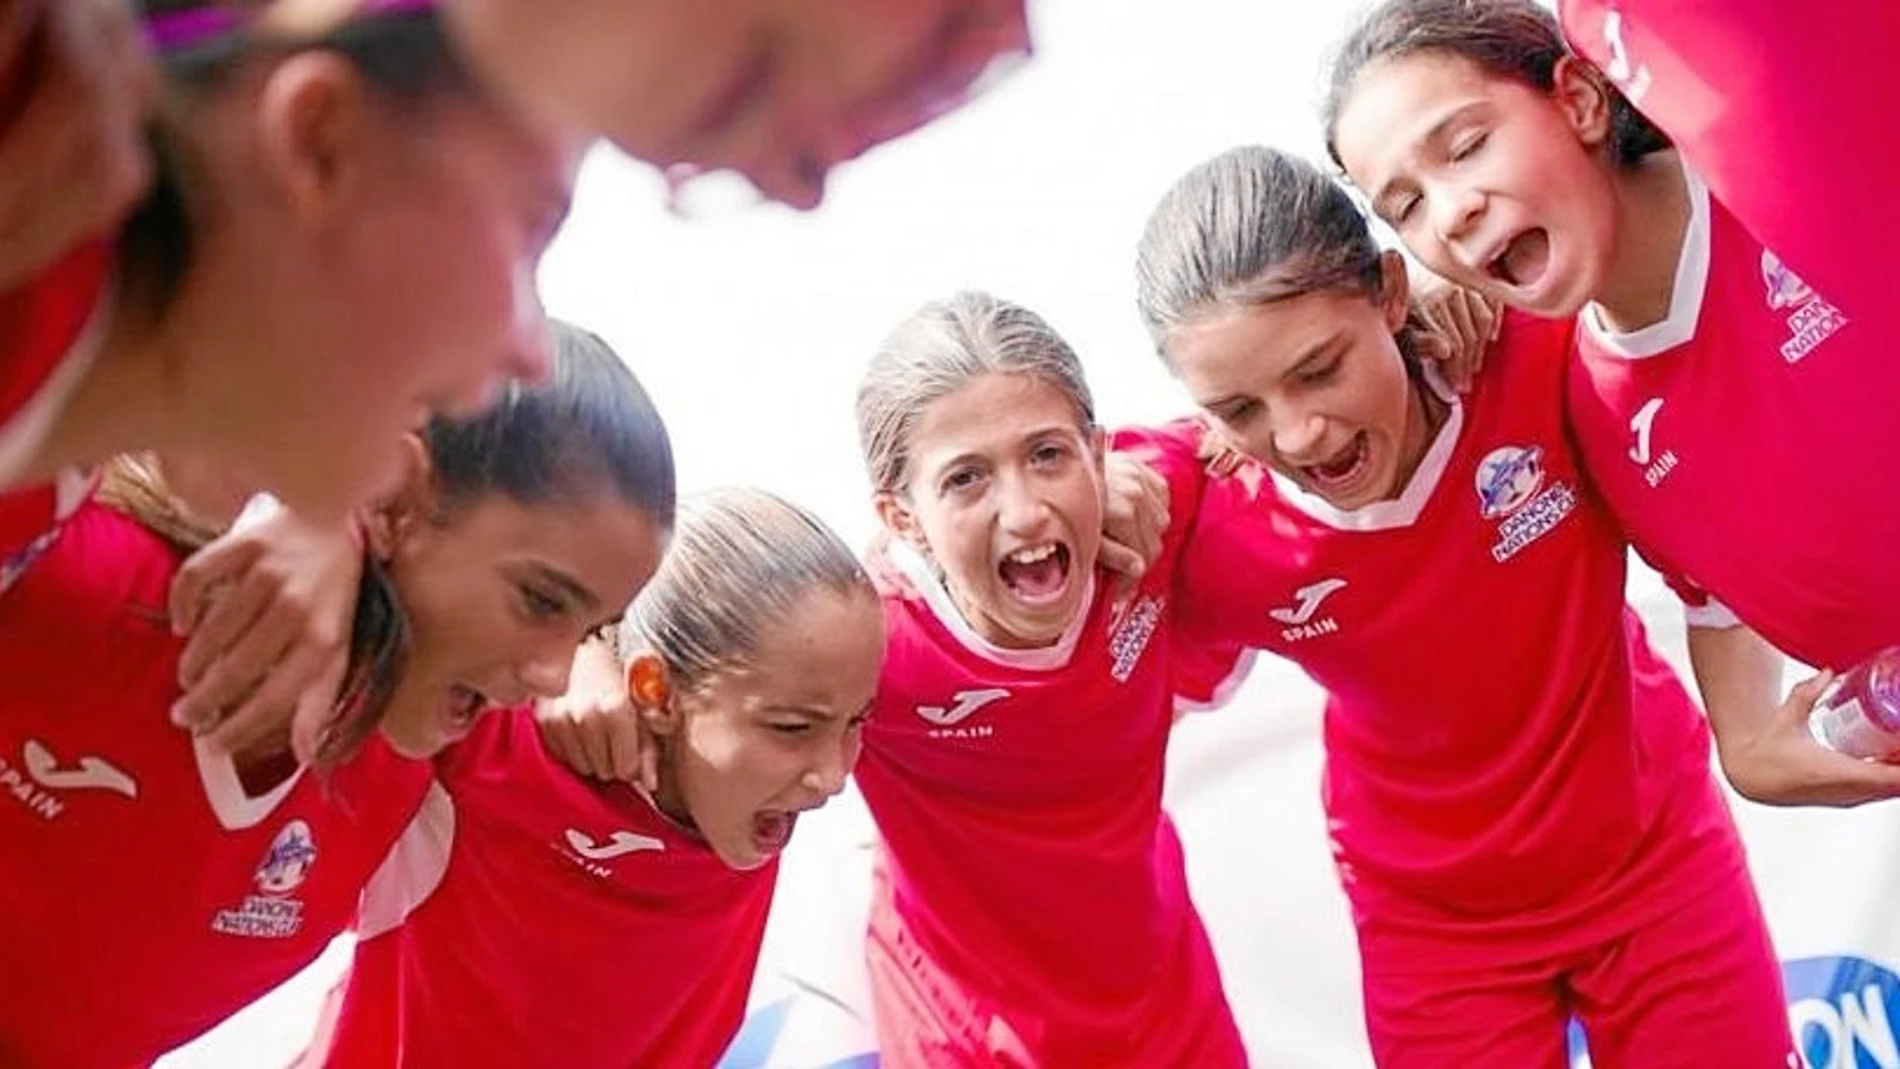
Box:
[0,503,428,1069]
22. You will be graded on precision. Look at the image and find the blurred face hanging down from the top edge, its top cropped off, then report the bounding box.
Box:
[448,0,1030,209]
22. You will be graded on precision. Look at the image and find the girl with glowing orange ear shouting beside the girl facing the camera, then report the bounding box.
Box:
[308,492,884,1069]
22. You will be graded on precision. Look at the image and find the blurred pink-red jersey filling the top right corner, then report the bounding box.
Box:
[1558,0,1900,328]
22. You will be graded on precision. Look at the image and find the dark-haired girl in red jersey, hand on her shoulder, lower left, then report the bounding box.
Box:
[0,320,673,1067]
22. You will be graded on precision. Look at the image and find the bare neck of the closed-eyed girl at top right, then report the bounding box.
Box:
[1596,152,1691,334]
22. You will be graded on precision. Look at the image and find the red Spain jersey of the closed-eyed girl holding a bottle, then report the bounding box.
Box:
[1569,177,1900,668]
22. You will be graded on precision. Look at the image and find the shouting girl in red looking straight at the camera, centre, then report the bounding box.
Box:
[857,294,1246,1069]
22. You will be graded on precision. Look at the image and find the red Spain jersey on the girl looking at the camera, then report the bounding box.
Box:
[857,455,1245,1069]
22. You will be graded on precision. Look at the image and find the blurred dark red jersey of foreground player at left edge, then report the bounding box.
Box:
[0,241,112,490]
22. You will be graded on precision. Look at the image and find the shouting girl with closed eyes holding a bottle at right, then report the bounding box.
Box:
[1328,0,1900,805]
